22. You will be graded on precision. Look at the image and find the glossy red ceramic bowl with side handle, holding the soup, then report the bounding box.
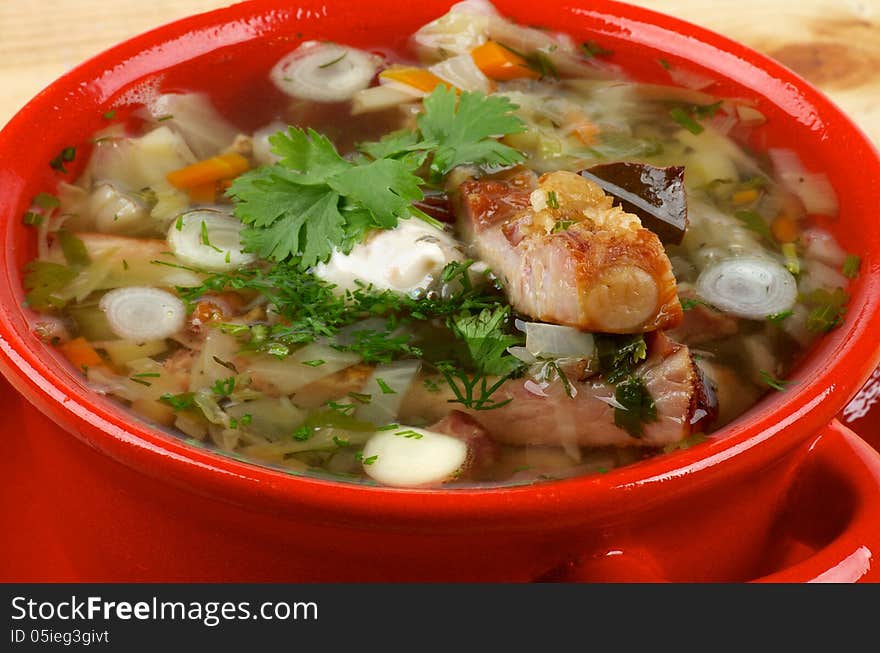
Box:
[0,0,880,581]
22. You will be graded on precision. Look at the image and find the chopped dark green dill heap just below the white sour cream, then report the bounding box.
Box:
[177,262,522,409]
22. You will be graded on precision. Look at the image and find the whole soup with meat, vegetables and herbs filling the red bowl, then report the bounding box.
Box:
[24,2,859,487]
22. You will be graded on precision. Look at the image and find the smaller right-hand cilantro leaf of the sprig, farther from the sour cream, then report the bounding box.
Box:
[418,85,525,178]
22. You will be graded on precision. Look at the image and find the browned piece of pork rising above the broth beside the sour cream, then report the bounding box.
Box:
[457,171,682,333]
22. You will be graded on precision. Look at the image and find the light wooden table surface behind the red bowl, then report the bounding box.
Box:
[0,0,880,143]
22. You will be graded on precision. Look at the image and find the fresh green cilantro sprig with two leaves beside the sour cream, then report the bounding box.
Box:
[229,85,525,270]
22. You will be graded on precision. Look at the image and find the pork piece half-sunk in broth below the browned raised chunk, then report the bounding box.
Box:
[400,333,717,447]
